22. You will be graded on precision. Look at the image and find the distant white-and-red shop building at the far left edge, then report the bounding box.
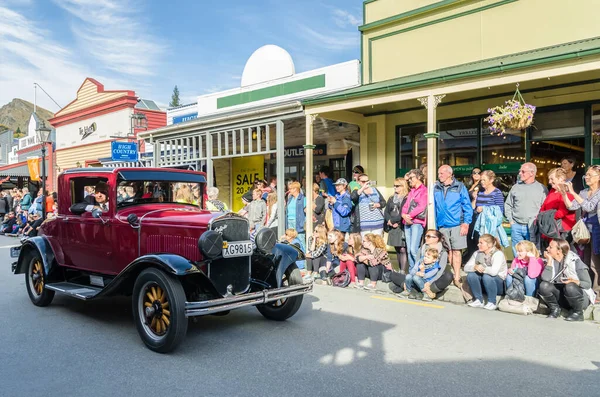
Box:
[0,112,56,192]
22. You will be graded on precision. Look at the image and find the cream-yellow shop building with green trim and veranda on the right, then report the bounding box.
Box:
[303,0,600,232]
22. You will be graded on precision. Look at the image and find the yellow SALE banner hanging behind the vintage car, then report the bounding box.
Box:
[231,155,265,212]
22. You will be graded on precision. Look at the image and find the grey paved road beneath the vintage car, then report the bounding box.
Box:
[0,237,600,397]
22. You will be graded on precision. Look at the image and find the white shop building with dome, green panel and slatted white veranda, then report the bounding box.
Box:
[140,45,361,232]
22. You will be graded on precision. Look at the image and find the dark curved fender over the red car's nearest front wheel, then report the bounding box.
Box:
[96,254,220,297]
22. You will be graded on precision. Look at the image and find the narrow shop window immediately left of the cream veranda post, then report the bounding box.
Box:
[397,124,427,176]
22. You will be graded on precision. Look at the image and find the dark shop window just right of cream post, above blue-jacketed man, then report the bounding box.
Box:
[438,119,479,169]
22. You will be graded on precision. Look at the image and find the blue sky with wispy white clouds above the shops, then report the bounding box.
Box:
[0,0,362,112]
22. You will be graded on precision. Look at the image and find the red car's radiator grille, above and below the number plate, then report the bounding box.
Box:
[208,214,250,295]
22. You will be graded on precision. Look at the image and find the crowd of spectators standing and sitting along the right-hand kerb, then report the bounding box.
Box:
[256,158,600,321]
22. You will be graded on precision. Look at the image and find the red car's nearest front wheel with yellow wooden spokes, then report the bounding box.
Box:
[132,268,188,353]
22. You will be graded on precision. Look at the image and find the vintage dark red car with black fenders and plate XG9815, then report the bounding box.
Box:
[12,168,312,352]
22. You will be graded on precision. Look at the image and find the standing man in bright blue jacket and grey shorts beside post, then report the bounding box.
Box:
[433,165,473,286]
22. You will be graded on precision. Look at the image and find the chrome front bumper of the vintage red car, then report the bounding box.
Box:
[185,283,313,317]
